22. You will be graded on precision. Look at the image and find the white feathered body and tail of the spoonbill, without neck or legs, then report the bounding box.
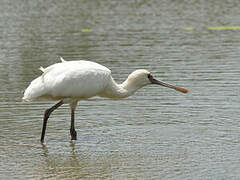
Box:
[23,61,111,101]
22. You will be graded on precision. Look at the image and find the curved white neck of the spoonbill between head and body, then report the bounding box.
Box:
[99,76,141,99]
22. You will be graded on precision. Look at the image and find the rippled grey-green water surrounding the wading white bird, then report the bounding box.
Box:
[0,0,240,179]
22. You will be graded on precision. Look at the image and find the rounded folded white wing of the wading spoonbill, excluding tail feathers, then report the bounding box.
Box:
[44,61,111,98]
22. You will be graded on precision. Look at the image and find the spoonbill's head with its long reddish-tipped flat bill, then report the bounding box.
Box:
[127,69,188,93]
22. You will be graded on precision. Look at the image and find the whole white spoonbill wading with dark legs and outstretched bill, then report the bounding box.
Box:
[22,58,188,143]
